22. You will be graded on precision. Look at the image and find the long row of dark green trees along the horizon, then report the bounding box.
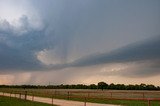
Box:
[0,82,160,90]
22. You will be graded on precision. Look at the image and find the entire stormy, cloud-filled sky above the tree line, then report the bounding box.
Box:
[0,0,160,86]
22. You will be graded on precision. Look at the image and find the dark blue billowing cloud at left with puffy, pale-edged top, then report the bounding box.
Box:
[0,15,54,71]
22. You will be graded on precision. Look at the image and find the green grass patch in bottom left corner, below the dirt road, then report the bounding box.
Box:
[0,96,55,106]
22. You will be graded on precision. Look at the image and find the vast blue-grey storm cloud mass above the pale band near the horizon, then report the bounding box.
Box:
[0,0,160,74]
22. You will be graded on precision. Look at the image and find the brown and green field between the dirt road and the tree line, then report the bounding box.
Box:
[0,89,160,106]
